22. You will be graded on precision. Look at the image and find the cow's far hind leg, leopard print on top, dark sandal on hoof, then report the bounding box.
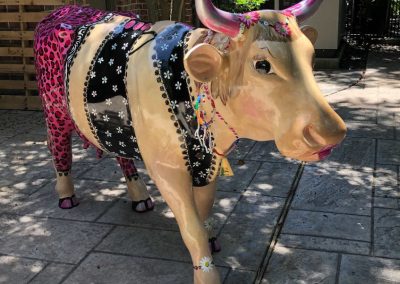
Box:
[117,157,154,213]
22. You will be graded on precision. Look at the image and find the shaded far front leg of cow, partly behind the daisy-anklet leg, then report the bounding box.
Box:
[193,179,221,252]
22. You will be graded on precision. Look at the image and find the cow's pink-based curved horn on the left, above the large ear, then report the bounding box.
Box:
[196,0,240,37]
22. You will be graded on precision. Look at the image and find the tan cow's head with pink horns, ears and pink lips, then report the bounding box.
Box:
[185,0,346,161]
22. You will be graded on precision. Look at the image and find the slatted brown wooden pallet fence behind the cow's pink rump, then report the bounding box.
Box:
[0,0,86,109]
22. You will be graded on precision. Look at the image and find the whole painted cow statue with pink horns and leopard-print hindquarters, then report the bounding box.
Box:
[35,0,346,283]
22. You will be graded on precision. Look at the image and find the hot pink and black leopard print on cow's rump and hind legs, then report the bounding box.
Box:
[34,5,141,179]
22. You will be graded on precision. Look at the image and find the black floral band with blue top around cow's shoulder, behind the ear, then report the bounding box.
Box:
[153,24,216,186]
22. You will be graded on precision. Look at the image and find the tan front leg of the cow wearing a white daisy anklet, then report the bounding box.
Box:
[148,164,220,284]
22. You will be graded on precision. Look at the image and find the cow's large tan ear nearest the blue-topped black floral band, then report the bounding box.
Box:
[183,43,224,83]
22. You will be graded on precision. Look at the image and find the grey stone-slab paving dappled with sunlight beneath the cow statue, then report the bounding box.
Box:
[0,47,400,284]
